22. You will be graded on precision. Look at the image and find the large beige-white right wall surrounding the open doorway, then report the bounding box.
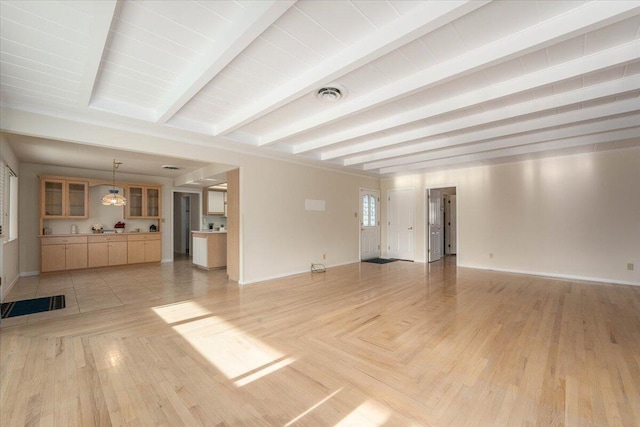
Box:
[381,148,640,284]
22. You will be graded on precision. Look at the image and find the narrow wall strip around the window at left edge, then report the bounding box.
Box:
[0,134,22,301]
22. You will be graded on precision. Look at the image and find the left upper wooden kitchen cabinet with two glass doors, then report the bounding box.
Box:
[40,177,89,219]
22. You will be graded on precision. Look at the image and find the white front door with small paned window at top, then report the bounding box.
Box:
[360,188,380,259]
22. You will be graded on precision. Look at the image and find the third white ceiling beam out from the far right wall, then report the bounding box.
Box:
[356,99,640,170]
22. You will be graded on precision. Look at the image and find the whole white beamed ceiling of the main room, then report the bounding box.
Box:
[0,0,640,176]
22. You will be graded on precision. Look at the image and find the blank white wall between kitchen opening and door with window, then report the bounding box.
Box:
[240,158,379,283]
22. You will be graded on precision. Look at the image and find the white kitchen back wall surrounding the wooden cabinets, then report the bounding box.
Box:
[19,163,173,274]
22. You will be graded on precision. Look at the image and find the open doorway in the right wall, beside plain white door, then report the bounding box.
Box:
[426,186,458,262]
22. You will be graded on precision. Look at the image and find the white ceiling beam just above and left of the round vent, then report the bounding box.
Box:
[216,0,488,135]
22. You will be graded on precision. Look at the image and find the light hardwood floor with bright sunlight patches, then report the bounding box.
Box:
[0,262,640,426]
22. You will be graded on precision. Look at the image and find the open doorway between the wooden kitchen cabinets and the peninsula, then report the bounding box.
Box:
[173,191,201,260]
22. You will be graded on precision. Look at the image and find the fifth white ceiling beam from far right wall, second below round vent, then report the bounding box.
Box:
[293,40,640,154]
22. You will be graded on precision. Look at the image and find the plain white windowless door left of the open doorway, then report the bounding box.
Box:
[388,189,415,261]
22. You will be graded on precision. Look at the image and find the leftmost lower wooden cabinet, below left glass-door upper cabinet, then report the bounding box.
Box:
[40,236,88,273]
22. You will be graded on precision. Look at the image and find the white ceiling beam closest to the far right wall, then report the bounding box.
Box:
[380,127,640,174]
